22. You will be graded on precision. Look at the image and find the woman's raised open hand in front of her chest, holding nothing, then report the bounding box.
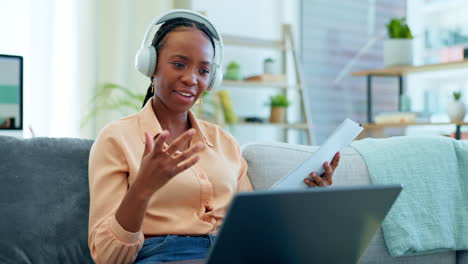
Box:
[136,128,204,198]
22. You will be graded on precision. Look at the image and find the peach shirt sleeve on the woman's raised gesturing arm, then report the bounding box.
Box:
[88,127,144,264]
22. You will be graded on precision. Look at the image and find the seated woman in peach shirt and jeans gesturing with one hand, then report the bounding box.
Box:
[88,11,339,263]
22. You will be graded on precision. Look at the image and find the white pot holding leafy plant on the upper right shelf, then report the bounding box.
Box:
[384,39,413,67]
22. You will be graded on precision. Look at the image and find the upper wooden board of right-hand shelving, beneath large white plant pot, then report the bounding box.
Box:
[352,60,468,76]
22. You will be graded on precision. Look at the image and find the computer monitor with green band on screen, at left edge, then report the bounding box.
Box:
[0,54,23,131]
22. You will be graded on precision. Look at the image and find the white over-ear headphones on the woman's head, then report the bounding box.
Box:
[135,9,223,90]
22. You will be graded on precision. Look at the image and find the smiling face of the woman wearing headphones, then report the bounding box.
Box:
[154,28,214,112]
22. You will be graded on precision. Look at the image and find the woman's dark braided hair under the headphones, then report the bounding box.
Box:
[141,18,216,108]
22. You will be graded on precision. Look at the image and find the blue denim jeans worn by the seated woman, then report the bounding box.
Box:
[135,235,215,264]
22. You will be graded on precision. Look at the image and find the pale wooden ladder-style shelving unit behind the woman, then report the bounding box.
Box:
[220,24,312,144]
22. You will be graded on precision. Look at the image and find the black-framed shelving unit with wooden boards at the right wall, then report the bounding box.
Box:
[352,60,468,139]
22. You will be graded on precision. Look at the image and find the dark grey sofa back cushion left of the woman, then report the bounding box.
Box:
[0,136,92,263]
